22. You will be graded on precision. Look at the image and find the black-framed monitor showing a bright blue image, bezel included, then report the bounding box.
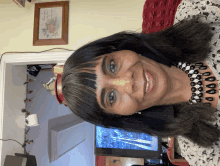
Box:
[95,125,162,159]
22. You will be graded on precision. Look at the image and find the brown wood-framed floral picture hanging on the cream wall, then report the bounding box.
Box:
[33,1,69,46]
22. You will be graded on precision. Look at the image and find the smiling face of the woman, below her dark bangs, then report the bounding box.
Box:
[95,50,169,115]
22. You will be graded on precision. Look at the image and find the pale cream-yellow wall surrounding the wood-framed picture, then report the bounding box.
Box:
[0,0,145,54]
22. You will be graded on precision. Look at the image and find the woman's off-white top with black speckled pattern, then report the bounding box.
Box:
[174,0,220,166]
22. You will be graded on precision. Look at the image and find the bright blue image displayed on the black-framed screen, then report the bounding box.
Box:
[96,126,158,151]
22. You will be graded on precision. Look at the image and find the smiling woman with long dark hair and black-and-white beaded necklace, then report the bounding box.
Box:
[62,1,220,165]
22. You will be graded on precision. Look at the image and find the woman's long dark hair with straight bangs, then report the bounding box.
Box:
[62,15,220,147]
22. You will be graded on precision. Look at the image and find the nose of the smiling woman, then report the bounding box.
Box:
[112,71,134,93]
